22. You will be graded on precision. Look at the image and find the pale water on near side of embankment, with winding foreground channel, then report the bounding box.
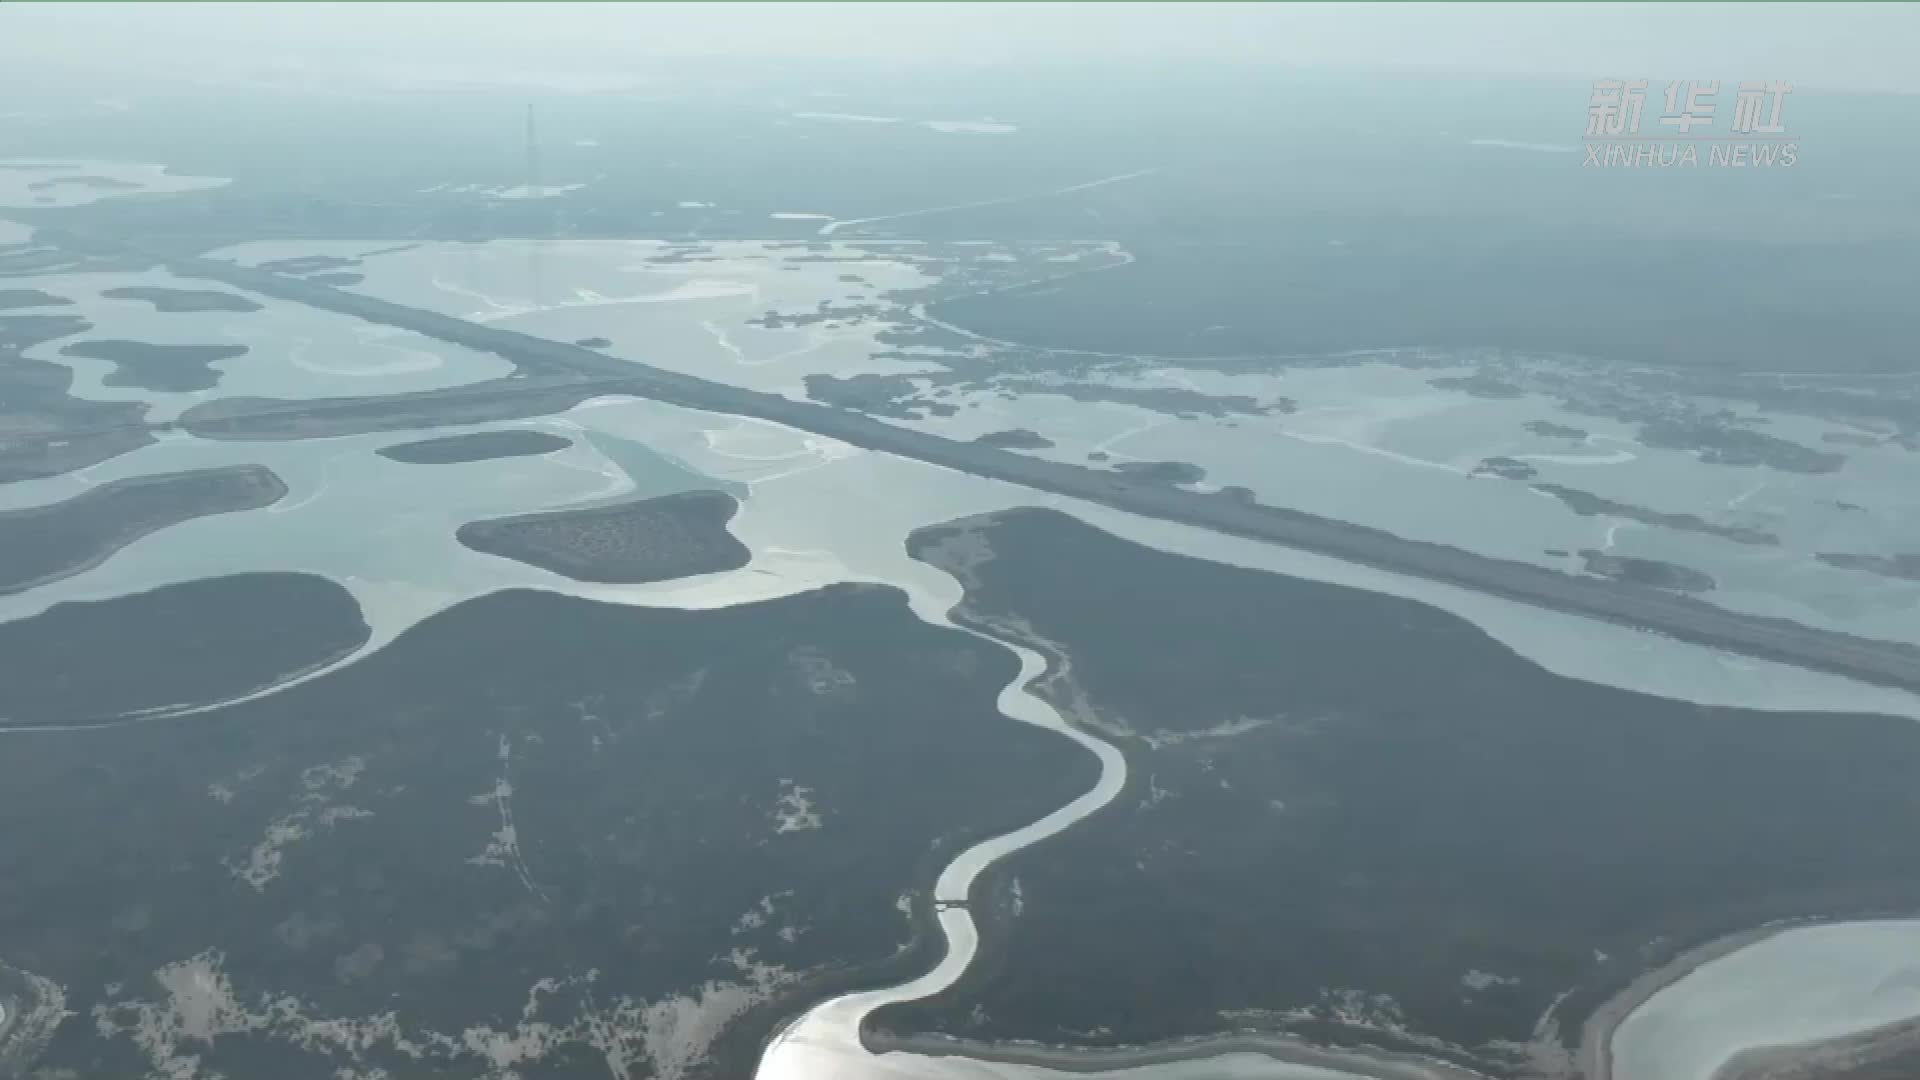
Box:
[0,398,1920,1080]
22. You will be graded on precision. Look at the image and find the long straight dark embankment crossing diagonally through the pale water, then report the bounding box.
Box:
[145,247,1920,692]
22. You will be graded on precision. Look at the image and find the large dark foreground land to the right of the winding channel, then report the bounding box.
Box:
[876,511,1920,1074]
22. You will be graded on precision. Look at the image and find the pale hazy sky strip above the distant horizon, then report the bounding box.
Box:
[11,4,1920,92]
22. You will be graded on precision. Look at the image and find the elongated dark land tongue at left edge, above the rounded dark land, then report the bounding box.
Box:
[0,465,286,596]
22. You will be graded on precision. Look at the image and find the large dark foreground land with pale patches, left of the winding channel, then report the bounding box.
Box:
[0,586,1094,1080]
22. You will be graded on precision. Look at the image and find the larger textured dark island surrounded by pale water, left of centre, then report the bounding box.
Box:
[455,492,751,584]
